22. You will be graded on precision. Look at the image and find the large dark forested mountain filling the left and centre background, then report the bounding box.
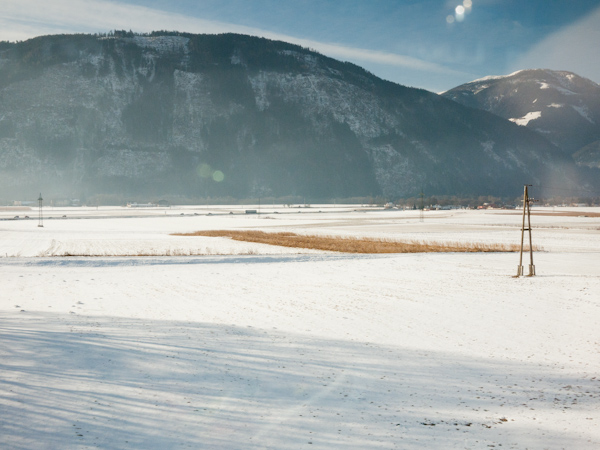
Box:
[0,32,584,199]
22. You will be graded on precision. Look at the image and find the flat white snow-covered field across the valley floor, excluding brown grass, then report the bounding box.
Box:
[0,206,600,450]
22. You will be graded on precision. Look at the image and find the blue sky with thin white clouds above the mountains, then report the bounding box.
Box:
[0,0,600,92]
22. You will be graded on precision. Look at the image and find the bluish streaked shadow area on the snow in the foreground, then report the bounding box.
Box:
[0,312,598,449]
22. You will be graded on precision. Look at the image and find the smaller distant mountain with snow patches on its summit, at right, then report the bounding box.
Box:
[442,69,600,167]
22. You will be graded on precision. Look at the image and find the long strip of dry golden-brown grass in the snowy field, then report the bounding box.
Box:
[174,230,520,253]
